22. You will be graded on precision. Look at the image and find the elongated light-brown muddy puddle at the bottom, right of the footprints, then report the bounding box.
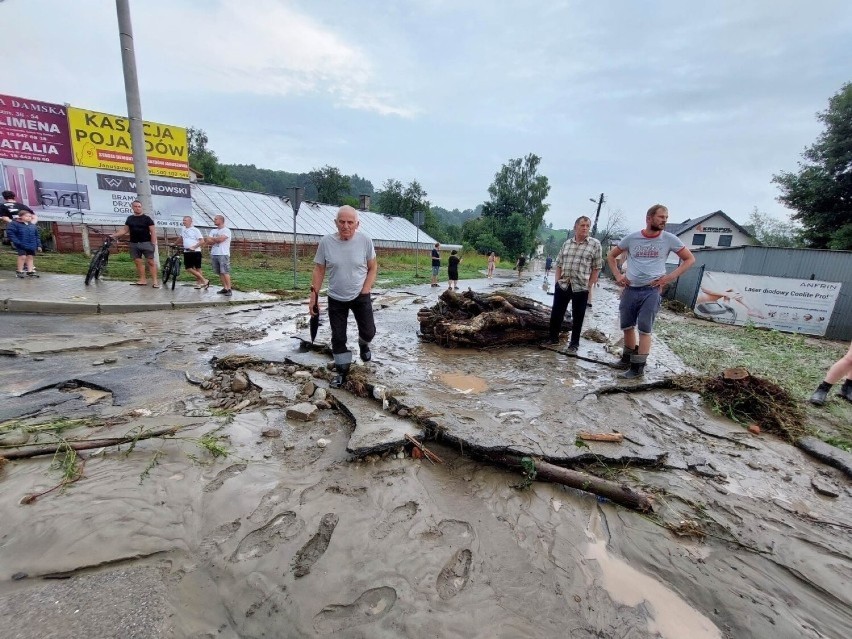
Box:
[586,509,722,639]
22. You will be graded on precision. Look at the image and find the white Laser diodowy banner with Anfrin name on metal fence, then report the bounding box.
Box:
[693,271,841,335]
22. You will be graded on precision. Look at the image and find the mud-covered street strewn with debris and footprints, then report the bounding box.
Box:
[0,274,852,639]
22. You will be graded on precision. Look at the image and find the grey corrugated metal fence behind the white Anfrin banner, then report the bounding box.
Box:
[666,246,852,340]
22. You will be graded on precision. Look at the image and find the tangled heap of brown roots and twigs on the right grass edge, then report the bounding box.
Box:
[671,368,807,442]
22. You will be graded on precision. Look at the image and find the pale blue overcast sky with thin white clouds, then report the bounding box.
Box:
[0,0,852,229]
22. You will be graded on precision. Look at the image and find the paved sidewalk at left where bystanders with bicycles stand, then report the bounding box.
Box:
[0,271,276,314]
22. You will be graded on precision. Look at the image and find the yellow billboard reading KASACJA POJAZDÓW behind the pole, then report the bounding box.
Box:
[68,107,189,179]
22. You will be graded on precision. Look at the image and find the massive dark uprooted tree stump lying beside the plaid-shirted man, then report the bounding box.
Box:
[417,290,571,348]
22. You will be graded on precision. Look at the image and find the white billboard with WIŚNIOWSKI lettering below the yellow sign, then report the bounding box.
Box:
[0,160,192,227]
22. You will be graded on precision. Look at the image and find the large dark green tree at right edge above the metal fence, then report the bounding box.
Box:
[772,83,852,250]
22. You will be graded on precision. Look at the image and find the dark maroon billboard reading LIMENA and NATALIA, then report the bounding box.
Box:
[0,94,71,166]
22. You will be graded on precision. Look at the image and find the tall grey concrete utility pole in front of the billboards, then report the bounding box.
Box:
[115,0,160,264]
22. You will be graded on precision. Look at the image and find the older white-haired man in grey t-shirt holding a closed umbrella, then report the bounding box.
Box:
[308,206,378,388]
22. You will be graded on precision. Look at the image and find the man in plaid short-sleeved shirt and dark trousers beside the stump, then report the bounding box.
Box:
[547,216,603,353]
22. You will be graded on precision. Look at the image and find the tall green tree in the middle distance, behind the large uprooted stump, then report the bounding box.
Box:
[482,153,550,254]
